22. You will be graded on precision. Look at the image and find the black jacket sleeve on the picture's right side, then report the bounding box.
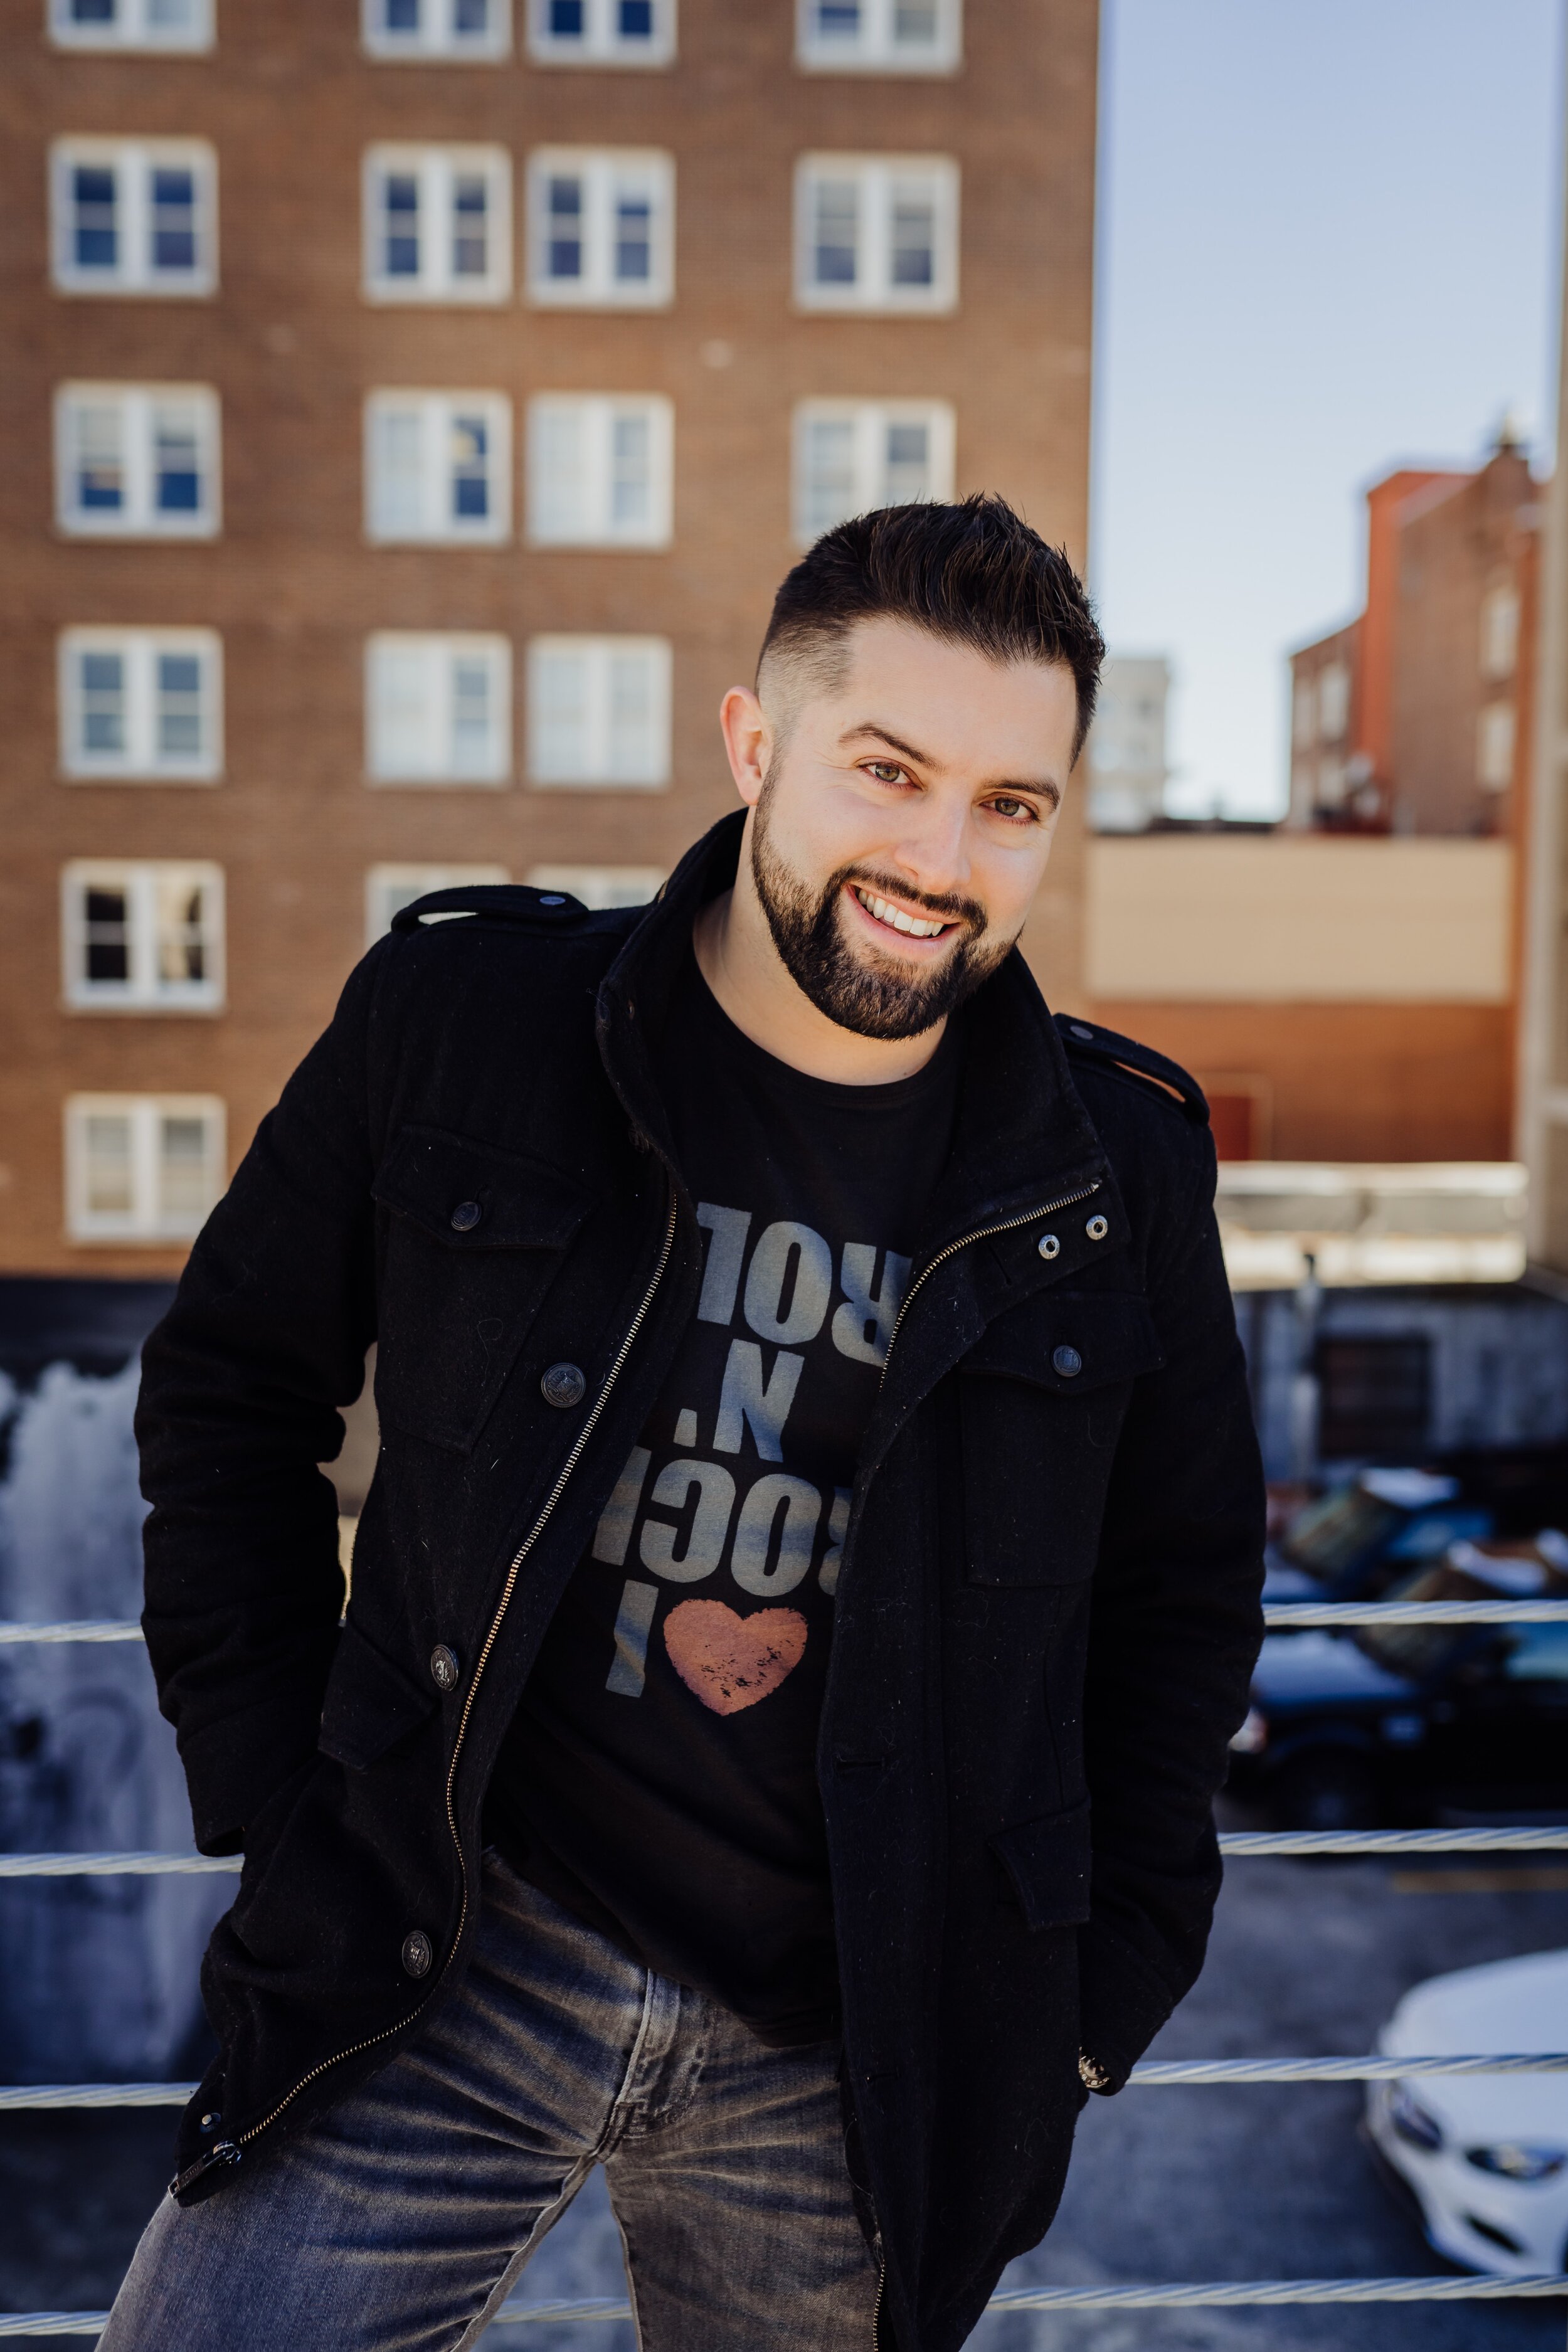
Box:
[1079,1113,1264,2091]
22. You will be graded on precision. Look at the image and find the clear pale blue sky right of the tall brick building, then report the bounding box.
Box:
[1091,0,1561,816]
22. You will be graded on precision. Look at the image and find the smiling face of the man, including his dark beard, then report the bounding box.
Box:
[731,621,1077,1040]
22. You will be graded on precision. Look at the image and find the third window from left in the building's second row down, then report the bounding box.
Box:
[529,148,675,310]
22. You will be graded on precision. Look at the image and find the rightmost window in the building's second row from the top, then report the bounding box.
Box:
[795,156,959,310]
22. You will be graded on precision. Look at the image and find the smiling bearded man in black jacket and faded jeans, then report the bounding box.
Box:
[103,499,1263,2352]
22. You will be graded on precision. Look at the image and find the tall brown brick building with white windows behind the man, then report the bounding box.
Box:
[0,0,1098,1275]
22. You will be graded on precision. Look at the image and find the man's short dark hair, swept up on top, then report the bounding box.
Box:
[757,492,1105,760]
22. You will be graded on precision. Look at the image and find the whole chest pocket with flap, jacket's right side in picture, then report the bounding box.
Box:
[959,1291,1163,1586]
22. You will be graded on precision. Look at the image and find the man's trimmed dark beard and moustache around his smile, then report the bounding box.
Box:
[752,778,1013,1042]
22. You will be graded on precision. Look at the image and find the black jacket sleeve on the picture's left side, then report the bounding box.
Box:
[136,950,383,1853]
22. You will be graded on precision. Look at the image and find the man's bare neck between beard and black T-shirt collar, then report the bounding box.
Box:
[691,824,947,1087]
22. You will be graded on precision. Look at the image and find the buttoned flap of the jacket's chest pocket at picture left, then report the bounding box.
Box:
[371,1126,593,1249]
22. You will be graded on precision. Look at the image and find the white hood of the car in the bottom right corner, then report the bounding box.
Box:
[1377,1952,1568,2148]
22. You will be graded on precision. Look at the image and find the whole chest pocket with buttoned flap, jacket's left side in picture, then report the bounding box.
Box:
[371,1126,595,1451]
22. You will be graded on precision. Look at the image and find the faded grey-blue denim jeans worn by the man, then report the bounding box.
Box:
[101,1856,877,2352]
